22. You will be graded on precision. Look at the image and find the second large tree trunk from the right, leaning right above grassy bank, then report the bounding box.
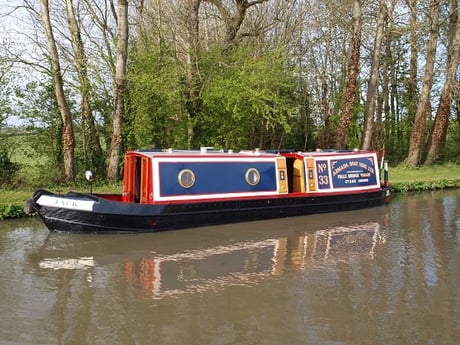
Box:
[406,0,440,167]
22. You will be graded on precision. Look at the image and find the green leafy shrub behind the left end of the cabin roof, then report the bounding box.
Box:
[125,46,187,148]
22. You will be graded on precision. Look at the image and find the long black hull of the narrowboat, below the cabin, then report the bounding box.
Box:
[32,188,389,233]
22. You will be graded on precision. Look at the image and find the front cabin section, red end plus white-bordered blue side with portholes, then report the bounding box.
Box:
[122,151,288,203]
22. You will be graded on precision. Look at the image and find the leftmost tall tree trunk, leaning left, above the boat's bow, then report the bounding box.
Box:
[40,0,75,182]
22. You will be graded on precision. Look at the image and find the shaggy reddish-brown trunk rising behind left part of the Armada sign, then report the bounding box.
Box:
[336,0,361,149]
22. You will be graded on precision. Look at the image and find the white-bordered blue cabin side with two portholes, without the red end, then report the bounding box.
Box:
[153,154,288,202]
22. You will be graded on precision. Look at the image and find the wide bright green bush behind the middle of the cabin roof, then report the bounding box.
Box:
[200,49,298,149]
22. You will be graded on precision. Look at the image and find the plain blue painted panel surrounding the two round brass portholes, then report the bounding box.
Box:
[159,162,277,197]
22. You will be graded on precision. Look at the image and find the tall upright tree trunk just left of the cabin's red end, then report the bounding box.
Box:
[107,0,128,180]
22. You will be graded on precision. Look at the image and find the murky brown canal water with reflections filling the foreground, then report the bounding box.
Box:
[0,190,460,345]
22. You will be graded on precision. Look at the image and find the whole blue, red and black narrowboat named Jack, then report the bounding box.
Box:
[25,147,390,233]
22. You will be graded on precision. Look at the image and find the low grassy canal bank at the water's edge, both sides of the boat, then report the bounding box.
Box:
[0,164,460,219]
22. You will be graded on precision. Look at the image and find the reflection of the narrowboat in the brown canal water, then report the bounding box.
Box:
[39,222,384,298]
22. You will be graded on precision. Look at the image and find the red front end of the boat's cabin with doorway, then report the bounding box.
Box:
[123,155,153,204]
